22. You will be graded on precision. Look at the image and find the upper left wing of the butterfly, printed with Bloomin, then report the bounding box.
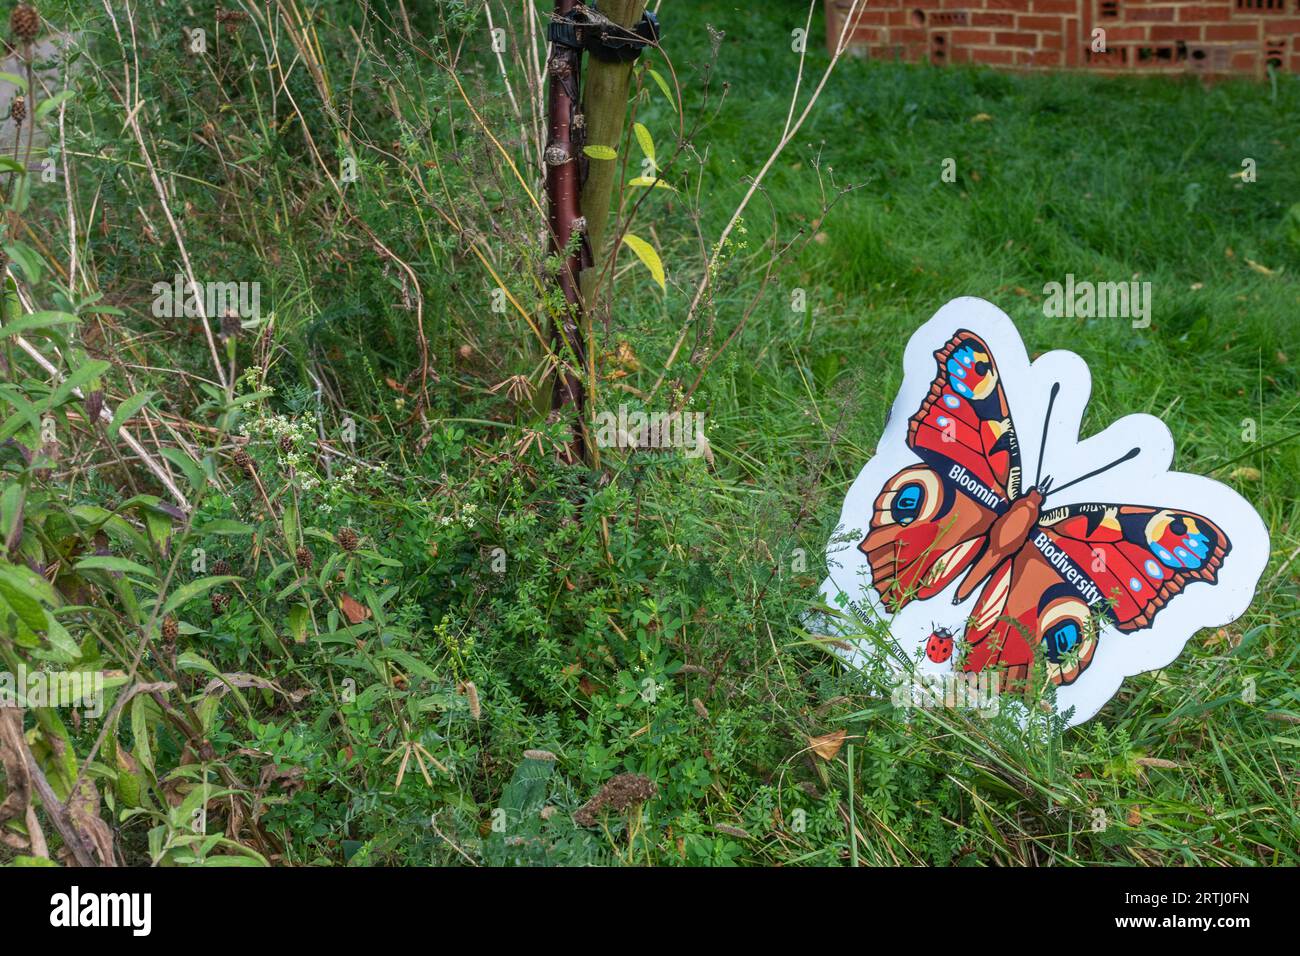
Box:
[907,329,1021,510]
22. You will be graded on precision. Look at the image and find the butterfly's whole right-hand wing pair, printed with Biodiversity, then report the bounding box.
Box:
[962,503,1231,684]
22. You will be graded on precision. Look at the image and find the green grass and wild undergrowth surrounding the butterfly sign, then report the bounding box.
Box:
[0,0,1300,865]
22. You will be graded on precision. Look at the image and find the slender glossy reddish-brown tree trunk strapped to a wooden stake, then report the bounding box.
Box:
[545,0,592,460]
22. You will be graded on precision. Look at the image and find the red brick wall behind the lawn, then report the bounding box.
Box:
[827,0,1300,77]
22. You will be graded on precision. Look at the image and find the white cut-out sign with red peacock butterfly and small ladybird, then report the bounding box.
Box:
[822,298,1269,726]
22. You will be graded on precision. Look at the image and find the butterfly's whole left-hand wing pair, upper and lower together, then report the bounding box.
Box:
[858,330,1021,611]
